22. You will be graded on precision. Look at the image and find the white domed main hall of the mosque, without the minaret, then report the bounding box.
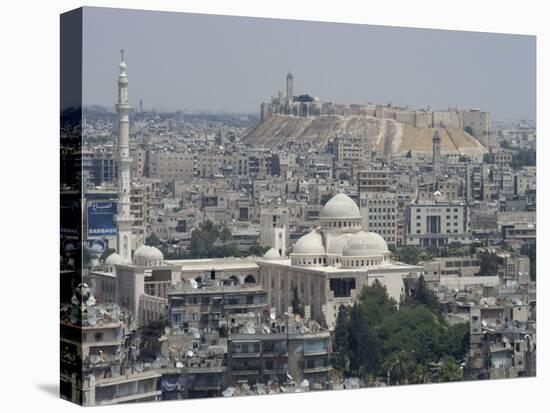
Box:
[257,193,422,329]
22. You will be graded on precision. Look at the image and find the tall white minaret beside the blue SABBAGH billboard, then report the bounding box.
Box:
[115,50,134,262]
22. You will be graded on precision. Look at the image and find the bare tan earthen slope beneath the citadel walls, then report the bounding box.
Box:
[243,115,487,158]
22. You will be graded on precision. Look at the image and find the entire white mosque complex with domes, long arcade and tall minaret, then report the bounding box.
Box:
[93,52,422,328]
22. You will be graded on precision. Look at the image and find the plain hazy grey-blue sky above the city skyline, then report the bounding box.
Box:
[83,8,536,120]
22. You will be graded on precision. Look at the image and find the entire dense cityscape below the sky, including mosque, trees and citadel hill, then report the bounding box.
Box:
[61,52,536,405]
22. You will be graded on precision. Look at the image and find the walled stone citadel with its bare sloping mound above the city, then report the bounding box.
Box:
[244,73,491,160]
